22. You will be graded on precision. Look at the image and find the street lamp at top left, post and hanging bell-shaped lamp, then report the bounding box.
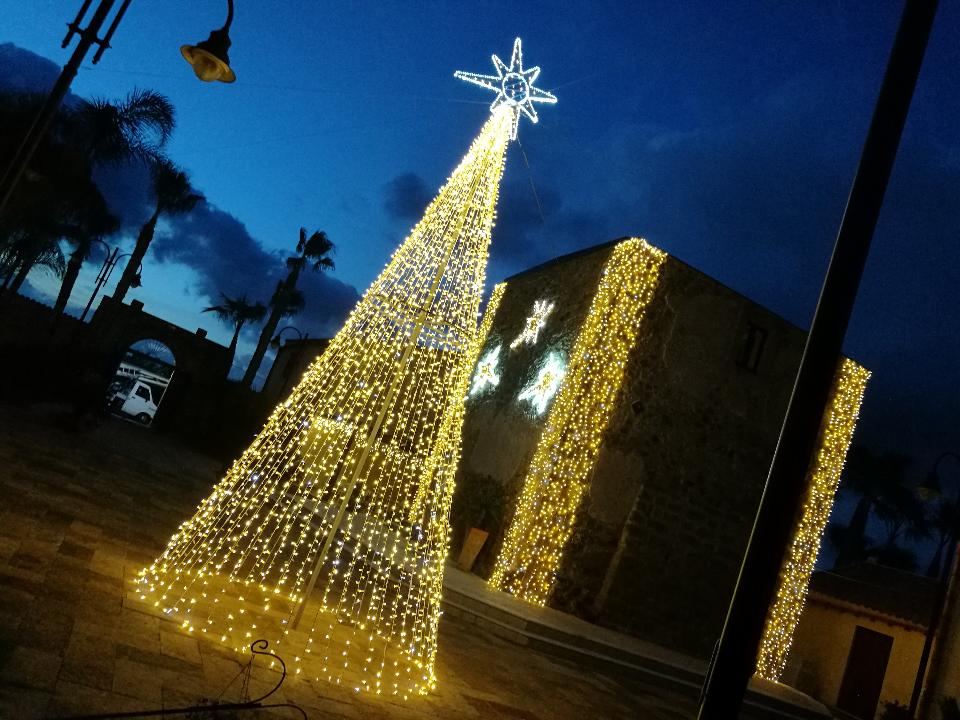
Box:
[0,0,236,214]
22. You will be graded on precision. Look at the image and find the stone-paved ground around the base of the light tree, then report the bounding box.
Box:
[0,406,824,720]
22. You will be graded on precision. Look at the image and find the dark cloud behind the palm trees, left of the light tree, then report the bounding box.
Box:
[151,202,359,337]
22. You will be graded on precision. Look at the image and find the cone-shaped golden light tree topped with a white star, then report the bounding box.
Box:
[136,39,556,696]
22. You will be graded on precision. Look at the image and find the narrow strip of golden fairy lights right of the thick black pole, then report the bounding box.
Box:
[757,360,870,680]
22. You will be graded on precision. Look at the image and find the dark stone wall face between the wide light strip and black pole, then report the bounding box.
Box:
[590,258,804,657]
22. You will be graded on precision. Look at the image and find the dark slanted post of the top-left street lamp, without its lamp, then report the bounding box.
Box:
[0,0,115,214]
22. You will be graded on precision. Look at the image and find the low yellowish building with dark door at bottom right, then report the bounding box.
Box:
[783,563,939,720]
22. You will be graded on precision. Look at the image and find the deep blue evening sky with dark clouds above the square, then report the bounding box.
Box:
[0,0,960,556]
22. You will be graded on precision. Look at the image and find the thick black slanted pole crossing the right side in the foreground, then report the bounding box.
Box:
[698,0,937,720]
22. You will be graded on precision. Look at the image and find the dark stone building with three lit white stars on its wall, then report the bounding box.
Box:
[454,240,859,658]
